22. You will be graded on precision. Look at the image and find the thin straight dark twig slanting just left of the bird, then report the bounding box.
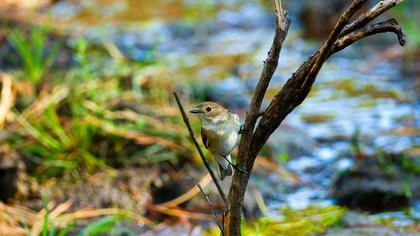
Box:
[174,92,227,206]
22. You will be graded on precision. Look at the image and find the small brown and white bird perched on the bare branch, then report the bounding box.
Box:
[190,102,241,180]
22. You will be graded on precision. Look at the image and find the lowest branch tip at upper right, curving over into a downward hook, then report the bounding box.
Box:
[330,19,406,54]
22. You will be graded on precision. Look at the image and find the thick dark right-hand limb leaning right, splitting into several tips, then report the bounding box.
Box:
[251,0,405,155]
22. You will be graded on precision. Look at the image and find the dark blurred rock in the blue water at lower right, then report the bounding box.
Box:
[332,155,420,212]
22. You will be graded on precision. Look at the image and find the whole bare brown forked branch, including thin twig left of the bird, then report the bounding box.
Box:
[175,0,406,236]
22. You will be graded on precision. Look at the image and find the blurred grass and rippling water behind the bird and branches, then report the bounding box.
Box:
[0,0,420,235]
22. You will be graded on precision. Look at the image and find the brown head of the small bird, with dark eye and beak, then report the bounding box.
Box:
[190,102,229,123]
